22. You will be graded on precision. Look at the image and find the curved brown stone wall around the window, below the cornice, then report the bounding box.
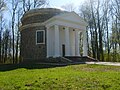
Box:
[21,26,47,60]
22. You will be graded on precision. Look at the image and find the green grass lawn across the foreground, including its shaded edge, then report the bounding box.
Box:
[0,64,120,90]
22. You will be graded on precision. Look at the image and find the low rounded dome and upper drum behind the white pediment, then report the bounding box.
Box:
[21,8,67,25]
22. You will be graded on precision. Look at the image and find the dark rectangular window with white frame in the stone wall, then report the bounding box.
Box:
[36,30,45,44]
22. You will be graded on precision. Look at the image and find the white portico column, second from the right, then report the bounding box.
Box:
[75,29,80,56]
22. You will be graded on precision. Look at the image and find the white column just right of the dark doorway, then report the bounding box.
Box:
[65,27,70,56]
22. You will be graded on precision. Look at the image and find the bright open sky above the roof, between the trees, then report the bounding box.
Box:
[49,0,85,11]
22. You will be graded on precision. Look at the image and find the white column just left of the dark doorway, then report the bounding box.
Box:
[55,25,60,57]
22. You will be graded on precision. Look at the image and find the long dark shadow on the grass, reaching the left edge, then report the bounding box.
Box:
[0,64,66,71]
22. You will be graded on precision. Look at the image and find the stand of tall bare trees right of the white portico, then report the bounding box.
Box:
[80,0,120,61]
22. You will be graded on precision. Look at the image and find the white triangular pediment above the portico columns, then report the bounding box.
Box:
[43,12,87,30]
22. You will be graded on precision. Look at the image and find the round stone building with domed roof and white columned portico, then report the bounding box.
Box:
[20,8,87,59]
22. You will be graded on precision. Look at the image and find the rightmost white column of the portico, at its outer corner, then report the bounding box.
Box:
[83,30,88,56]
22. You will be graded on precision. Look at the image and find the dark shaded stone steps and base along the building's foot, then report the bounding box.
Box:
[22,56,98,64]
